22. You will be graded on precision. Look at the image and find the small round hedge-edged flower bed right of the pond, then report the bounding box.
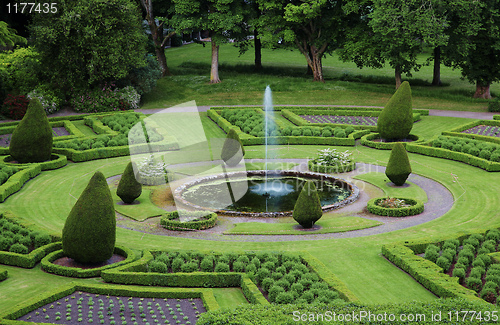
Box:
[366,197,424,217]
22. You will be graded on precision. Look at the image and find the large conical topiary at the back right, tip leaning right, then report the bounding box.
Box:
[377,81,413,140]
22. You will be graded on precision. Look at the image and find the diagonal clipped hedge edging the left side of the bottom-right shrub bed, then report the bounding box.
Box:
[382,242,487,304]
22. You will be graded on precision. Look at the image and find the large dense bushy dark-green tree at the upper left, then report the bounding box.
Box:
[31,0,146,91]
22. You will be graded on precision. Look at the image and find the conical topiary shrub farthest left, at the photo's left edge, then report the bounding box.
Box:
[9,98,52,163]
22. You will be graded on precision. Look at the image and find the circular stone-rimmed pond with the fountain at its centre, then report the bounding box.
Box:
[174,170,359,217]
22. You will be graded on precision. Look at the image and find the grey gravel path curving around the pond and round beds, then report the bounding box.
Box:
[114,159,454,242]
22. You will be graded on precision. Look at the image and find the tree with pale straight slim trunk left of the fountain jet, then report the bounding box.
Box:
[172,0,245,83]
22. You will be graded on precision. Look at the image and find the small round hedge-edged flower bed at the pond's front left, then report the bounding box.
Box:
[160,211,217,231]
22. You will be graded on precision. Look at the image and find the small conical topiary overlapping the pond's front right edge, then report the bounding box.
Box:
[292,181,323,228]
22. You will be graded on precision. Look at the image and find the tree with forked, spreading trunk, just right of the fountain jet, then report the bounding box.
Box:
[257,0,345,81]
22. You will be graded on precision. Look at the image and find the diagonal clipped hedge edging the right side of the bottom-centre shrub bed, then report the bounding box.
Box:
[300,251,360,302]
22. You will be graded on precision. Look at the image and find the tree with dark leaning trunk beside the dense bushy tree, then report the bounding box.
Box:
[140,0,176,76]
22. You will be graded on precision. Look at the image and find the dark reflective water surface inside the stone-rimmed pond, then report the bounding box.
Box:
[182,176,351,212]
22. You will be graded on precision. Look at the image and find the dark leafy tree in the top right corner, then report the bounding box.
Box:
[443,0,500,99]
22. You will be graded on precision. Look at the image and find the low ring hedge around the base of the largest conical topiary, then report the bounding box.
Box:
[41,246,136,278]
